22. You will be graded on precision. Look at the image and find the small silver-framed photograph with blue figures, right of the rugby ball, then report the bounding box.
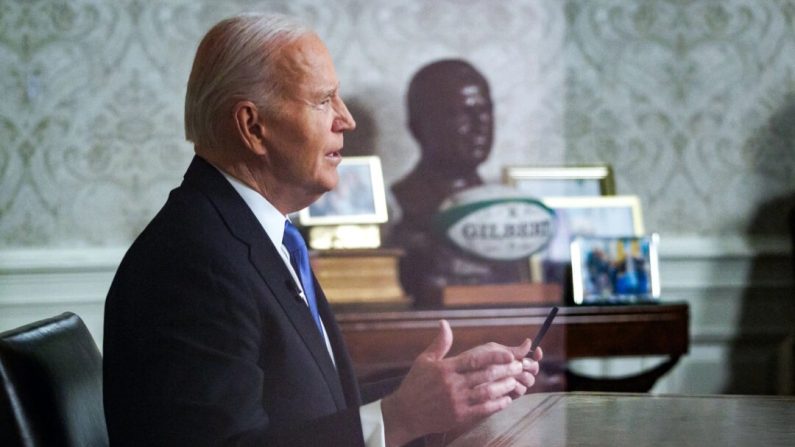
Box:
[571,234,660,304]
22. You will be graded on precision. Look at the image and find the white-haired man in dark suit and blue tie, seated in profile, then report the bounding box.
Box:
[104,14,541,446]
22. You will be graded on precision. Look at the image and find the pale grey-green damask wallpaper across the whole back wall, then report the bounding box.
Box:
[0,0,795,248]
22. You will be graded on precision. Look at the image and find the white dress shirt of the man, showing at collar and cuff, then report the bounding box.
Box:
[216,167,386,447]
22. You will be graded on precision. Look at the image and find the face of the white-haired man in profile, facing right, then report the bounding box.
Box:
[262,34,356,209]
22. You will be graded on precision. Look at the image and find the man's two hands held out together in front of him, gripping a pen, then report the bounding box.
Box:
[381,320,541,446]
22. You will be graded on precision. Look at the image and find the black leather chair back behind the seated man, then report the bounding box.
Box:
[0,312,108,447]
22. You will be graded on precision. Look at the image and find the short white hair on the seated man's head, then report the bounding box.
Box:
[185,13,312,150]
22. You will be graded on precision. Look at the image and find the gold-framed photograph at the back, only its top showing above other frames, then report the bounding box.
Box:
[502,165,616,197]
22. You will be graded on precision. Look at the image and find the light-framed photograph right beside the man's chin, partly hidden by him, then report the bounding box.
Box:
[298,156,387,226]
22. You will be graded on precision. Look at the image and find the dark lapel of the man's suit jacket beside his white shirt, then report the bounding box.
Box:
[184,157,347,408]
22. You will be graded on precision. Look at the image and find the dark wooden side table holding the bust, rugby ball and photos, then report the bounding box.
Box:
[335,304,689,391]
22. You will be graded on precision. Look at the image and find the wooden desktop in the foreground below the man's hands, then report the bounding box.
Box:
[444,393,795,447]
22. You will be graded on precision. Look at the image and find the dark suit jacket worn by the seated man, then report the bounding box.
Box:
[104,157,370,447]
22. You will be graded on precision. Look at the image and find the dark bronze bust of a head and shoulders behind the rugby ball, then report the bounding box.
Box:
[391,59,522,305]
